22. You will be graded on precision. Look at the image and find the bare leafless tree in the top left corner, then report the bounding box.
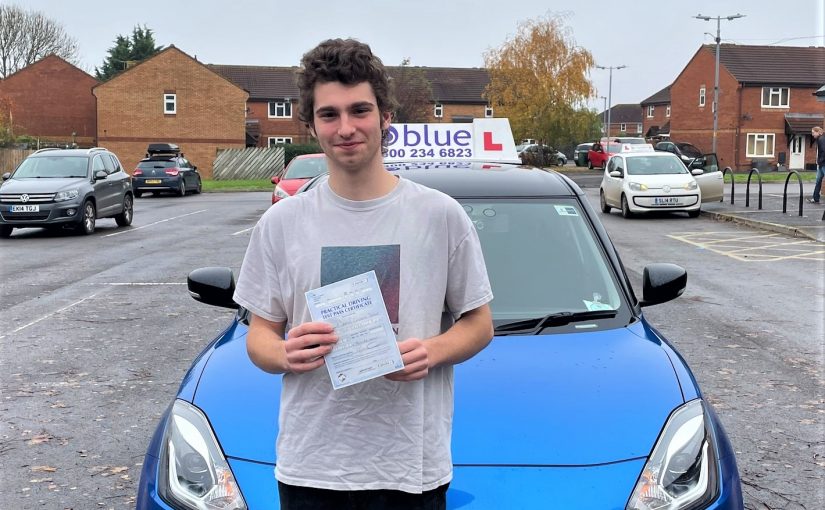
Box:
[0,5,78,78]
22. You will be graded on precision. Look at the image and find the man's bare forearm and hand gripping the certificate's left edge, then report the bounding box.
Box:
[246,313,338,374]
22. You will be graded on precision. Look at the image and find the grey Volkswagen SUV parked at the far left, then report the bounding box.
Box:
[0,147,134,238]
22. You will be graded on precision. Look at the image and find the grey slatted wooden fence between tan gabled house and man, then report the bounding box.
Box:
[212,147,284,181]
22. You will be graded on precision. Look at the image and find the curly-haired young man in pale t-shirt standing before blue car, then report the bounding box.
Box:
[235,39,493,510]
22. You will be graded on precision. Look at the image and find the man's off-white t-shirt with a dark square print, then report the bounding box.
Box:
[235,178,493,493]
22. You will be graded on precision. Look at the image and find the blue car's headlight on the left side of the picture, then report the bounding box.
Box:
[158,400,247,510]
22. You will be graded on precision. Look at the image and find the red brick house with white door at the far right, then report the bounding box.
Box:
[670,44,825,169]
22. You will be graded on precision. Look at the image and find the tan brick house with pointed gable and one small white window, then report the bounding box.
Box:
[92,46,249,179]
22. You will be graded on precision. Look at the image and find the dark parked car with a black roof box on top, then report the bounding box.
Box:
[132,143,202,197]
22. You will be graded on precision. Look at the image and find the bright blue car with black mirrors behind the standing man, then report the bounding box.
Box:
[137,162,743,510]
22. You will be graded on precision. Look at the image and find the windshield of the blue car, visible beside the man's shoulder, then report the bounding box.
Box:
[459,198,622,320]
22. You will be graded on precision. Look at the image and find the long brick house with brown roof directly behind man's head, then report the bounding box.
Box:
[208,64,493,147]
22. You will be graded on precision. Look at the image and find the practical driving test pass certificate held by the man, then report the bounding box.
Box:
[306,271,404,390]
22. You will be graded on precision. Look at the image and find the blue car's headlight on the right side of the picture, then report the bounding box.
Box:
[627,399,719,510]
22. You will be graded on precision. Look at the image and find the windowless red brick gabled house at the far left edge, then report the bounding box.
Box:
[0,54,98,147]
